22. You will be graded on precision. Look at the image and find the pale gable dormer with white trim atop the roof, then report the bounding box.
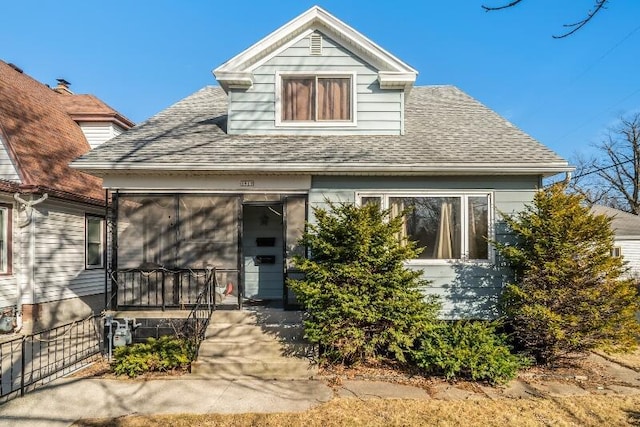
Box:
[213,6,417,135]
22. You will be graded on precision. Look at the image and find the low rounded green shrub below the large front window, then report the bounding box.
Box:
[412,321,528,384]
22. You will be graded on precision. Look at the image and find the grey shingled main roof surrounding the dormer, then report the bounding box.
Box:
[73,86,571,175]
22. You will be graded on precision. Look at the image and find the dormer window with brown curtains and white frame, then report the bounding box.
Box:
[276,74,355,126]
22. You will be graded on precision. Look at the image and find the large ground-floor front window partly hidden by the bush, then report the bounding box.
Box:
[360,194,490,260]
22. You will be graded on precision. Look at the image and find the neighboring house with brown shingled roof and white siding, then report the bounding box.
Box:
[0,61,133,332]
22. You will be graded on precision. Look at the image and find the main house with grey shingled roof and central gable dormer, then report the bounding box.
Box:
[73,7,572,317]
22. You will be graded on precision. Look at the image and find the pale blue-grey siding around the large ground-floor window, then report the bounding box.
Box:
[309,176,536,319]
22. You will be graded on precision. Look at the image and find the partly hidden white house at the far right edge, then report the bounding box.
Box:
[591,205,640,278]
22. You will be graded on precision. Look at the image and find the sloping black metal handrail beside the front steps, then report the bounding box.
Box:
[182,268,218,360]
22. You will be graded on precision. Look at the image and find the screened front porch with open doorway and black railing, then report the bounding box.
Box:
[110,193,307,310]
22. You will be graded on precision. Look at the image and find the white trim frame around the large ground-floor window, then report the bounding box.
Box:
[356,190,495,266]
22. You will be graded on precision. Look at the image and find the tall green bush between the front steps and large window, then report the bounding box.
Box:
[289,203,439,364]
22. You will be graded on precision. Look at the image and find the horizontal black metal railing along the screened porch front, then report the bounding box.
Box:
[112,268,211,310]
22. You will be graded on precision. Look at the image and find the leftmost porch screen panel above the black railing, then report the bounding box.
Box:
[117,196,178,269]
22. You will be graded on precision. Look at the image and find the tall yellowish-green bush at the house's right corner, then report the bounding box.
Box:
[496,185,639,363]
